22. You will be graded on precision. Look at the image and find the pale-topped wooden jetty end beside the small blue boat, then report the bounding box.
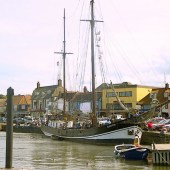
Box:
[152,144,170,166]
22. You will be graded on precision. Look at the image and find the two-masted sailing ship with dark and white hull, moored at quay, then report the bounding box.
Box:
[41,0,142,144]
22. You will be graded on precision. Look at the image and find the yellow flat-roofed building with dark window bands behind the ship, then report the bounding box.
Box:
[96,82,156,115]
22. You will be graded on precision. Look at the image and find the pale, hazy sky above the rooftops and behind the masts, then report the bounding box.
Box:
[0,0,170,95]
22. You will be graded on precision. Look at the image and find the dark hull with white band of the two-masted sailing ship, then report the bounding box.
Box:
[41,124,142,145]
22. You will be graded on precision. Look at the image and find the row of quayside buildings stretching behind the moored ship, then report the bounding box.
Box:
[0,79,170,118]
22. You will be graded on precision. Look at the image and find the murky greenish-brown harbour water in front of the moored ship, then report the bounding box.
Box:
[0,132,169,170]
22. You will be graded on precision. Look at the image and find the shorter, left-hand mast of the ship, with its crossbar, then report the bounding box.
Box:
[54,8,73,114]
